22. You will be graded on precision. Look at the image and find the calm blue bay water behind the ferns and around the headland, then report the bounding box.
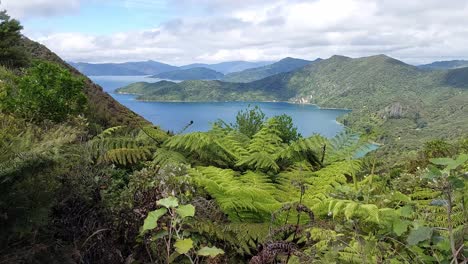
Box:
[90,76,348,137]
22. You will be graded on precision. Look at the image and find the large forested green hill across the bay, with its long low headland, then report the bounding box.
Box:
[118,55,468,159]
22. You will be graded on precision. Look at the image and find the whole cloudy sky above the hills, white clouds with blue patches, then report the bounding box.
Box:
[0,0,468,65]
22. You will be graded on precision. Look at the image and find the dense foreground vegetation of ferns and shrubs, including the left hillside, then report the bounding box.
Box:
[0,9,468,264]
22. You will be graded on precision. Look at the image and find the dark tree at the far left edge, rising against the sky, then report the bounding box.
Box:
[0,10,28,68]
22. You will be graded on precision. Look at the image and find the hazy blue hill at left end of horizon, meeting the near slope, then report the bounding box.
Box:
[70,60,178,76]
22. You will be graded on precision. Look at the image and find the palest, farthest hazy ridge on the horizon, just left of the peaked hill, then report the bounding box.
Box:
[180,61,273,74]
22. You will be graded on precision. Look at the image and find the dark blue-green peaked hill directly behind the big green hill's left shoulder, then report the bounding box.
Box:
[223,58,320,83]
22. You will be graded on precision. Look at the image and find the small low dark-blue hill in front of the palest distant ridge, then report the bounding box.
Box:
[151,67,224,80]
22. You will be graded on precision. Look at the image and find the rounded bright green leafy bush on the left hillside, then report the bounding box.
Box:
[7,62,86,122]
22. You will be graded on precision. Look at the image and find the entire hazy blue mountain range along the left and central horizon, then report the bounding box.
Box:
[69,60,273,76]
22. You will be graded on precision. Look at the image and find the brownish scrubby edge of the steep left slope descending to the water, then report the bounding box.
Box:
[22,38,147,127]
